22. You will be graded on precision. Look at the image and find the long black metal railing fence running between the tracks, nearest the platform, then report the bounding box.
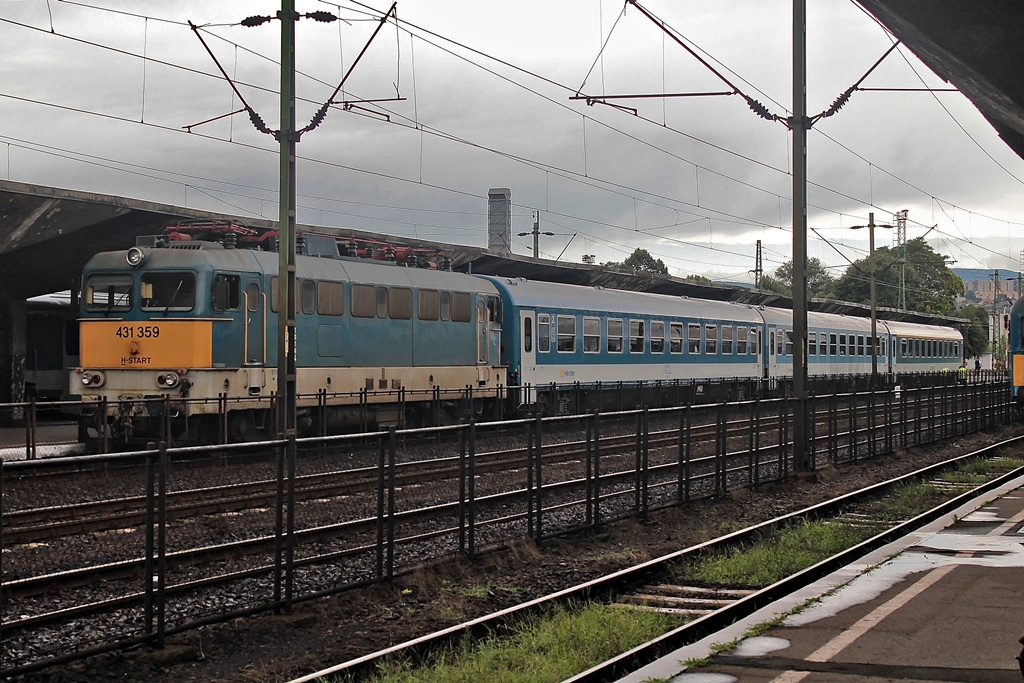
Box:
[0,378,1017,676]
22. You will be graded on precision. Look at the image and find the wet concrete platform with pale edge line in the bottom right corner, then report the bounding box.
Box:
[622,478,1024,683]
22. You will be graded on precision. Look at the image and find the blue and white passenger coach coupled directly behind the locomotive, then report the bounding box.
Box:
[488,278,763,403]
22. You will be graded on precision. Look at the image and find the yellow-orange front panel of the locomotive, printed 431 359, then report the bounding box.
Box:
[79,321,213,370]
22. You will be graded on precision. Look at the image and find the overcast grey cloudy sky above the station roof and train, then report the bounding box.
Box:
[0,0,1024,280]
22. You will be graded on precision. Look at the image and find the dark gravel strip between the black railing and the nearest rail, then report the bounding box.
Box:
[23,425,1024,683]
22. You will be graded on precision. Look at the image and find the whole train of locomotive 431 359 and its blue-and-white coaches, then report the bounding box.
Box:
[70,221,964,443]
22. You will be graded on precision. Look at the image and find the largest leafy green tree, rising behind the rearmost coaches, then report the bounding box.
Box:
[835,238,964,315]
